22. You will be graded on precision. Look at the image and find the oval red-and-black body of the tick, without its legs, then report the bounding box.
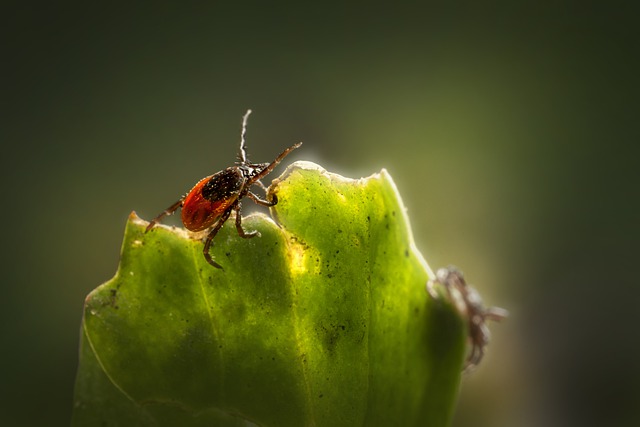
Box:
[182,166,246,231]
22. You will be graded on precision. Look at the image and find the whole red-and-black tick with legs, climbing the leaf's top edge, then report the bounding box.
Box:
[145,110,302,268]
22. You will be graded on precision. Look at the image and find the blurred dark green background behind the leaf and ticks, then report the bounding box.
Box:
[0,2,640,427]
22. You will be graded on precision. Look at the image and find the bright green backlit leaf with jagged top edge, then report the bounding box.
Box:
[73,162,466,427]
